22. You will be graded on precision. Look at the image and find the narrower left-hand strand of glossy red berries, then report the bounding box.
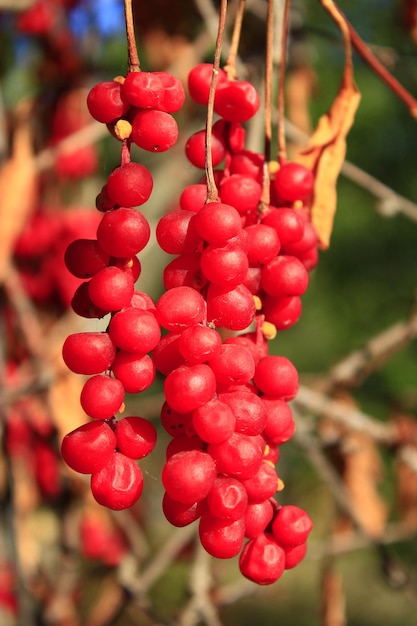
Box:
[61,72,184,509]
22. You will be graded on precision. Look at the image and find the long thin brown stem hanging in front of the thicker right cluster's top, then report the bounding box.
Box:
[205,0,227,203]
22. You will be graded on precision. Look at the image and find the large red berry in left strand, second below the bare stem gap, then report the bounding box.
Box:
[97,207,150,258]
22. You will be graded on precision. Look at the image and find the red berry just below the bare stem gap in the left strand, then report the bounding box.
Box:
[106,161,153,207]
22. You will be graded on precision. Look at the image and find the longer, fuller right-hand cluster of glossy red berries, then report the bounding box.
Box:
[148,64,317,584]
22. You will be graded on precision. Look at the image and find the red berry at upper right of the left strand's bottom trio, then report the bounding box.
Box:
[114,416,157,460]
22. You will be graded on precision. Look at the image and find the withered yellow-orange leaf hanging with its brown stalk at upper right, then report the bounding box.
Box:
[295,0,361,249]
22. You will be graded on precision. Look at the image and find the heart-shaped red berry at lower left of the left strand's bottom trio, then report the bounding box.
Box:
[61,421,116,474]
